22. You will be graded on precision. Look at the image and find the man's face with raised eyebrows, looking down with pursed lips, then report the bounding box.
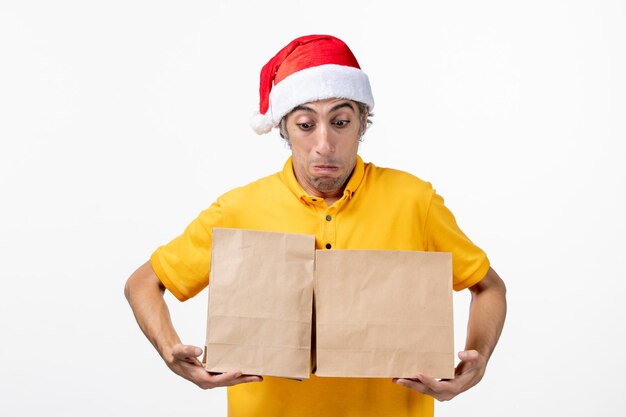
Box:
[286,99,360,198]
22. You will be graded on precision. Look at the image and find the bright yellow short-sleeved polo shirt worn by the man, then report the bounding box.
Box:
[150,157,489,417]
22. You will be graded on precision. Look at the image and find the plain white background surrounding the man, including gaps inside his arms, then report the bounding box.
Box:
[0,0,626,417]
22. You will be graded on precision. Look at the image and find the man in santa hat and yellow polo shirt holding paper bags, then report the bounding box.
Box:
[125,35,506,417]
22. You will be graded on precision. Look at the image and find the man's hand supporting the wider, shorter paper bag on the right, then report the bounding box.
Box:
[393,350,487,401]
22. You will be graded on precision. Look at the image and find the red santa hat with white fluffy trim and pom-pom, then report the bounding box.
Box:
[250,35,374,135]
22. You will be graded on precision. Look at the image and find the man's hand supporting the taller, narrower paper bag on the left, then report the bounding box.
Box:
[165,344,263,389]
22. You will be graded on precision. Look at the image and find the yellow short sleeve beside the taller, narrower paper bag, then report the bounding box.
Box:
[150,200,222,301]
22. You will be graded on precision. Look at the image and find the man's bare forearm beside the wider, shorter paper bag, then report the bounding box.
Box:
[465,268,506,360]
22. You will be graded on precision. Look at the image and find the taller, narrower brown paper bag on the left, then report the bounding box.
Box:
[205,228,315,379]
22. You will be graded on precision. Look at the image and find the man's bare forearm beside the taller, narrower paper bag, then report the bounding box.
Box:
[124,262,180,362]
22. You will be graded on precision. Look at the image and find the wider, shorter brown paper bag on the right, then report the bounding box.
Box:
[315,250,454,378]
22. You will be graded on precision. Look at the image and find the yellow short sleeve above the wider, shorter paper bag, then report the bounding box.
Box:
[424,191,489,291]
